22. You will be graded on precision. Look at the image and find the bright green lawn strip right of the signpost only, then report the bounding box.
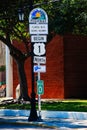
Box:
[42,102,87,112]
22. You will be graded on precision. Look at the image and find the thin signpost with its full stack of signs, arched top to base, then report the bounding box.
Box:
[29,8,48,119]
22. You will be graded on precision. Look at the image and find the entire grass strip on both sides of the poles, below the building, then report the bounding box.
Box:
[0,100,87,112]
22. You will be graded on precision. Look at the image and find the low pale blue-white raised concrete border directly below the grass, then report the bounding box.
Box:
[0,109,87,120]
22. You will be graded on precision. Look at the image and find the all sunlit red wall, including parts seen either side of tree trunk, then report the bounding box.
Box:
[13,36,64,98]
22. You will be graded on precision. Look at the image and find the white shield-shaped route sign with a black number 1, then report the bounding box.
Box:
[33,43,46,56]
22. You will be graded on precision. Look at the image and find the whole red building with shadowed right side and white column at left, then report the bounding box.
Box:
[0,35,87,99]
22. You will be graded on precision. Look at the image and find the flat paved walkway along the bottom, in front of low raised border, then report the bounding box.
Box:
[0,116,87,130]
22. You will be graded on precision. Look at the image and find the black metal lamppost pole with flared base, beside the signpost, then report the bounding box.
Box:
[28,0,38,121]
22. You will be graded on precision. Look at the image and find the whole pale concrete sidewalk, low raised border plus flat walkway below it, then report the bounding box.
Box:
[0,109,87,130]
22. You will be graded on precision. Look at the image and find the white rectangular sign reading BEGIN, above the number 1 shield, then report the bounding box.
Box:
[31,35,47,42]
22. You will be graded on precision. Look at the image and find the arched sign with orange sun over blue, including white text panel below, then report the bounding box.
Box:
[29,8,48,35]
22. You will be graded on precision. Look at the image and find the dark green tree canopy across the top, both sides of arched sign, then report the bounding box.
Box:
[0,0,87,44]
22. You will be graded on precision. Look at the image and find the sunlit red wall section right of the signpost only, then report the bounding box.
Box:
[42,36,64,98]
